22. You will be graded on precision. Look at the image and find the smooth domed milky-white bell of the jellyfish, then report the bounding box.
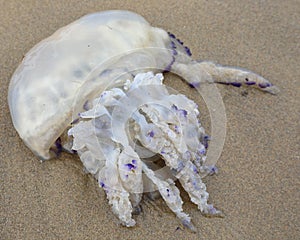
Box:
[8,11,169,159]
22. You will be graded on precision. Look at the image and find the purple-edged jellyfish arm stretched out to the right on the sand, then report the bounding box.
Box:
[169,36,279,94]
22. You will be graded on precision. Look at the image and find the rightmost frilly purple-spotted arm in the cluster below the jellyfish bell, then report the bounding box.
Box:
[134,88,221,215]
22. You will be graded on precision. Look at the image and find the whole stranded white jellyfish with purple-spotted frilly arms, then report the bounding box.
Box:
[8,11,277,228]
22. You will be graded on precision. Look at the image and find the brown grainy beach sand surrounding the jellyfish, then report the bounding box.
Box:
[0,0,300,240]
